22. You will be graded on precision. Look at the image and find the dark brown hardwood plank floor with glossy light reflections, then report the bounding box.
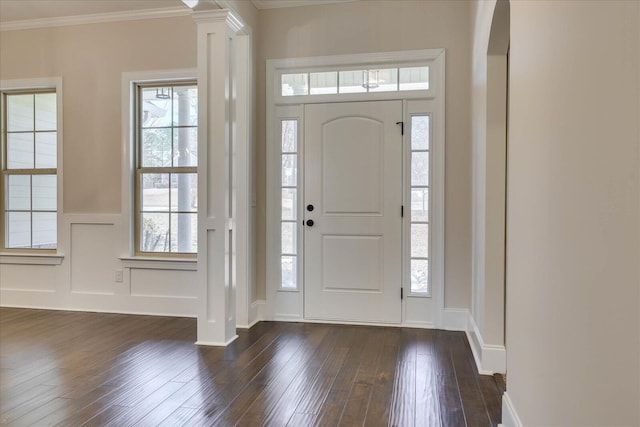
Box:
[0,308,503,427]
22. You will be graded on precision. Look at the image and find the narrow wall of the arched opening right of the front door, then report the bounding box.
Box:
[469,0,509,372]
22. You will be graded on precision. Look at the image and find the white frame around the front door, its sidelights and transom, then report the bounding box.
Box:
[265,49,445,328]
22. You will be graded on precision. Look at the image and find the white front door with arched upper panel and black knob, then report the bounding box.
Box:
[304,101,402,323]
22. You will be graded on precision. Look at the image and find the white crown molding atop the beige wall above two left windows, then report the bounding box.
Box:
[0,6,191,31]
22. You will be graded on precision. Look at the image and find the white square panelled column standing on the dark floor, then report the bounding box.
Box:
[192,10,242,346]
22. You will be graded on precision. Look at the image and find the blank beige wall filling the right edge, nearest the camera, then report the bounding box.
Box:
[506,1,640,427]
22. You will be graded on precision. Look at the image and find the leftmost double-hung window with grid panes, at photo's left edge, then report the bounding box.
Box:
[0,89,58,250]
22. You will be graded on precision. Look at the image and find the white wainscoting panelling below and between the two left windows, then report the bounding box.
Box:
[0,214,197,317]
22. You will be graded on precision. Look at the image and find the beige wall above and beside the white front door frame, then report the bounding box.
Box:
[256,0,471,309]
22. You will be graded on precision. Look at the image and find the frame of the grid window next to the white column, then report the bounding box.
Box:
[130,78,200,260]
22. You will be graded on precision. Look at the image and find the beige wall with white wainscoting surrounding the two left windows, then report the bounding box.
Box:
[0,16,196,316]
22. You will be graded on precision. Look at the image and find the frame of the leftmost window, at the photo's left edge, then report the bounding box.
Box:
[0,77,64,254]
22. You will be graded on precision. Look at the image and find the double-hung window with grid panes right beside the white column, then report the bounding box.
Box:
[135,81,198,256]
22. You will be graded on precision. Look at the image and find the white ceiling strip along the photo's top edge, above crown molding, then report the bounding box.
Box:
[0,0,352,23]
